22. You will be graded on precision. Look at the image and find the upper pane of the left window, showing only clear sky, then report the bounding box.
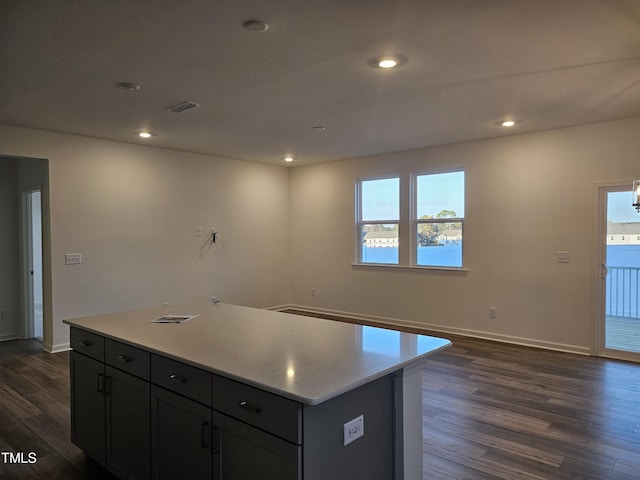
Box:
[361,178,400,221]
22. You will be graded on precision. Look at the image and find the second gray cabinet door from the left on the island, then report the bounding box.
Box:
[105,366,151,480]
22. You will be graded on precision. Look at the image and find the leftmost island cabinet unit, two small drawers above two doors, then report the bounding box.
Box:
[70,329,151,480]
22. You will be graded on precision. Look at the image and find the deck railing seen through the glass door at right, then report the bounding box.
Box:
[606,267,640,318]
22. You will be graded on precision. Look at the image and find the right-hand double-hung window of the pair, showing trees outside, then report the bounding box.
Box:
[412,171,464,267]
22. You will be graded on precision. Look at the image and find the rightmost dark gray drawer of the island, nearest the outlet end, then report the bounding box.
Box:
[213,375,302,445]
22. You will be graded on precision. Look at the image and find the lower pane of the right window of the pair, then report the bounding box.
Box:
[416,222,462,267]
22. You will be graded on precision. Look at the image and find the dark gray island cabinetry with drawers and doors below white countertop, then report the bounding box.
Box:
[71,328,395,480]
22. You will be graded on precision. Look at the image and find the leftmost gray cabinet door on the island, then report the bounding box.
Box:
[69,351,105,467]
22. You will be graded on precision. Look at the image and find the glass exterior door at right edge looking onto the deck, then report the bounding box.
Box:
[598,182,640,362]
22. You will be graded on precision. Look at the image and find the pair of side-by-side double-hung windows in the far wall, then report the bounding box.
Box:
[356,170,464,268]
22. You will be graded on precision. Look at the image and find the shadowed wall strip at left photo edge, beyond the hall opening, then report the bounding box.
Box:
[0,158,20,340]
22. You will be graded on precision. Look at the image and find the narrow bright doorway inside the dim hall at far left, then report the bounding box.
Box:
[22,186,44,342]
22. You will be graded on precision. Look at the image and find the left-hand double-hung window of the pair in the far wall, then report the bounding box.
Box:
[358,177,400,265]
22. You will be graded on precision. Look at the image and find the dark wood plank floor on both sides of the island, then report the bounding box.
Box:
[0,338,640,480]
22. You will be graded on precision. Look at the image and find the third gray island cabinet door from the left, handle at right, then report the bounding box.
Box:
[151,385,212,480]
